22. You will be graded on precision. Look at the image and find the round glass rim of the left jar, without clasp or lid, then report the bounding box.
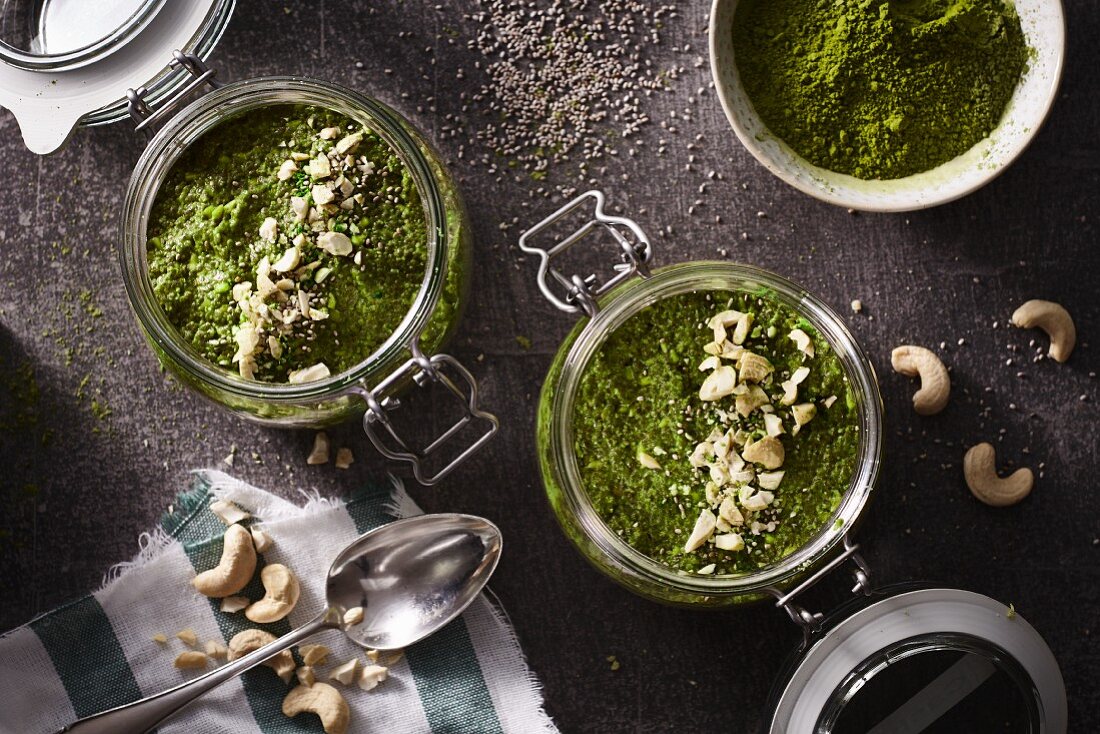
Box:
[119,76,454,403]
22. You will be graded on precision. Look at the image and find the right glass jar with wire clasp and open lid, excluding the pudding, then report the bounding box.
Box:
[519,191,1067,734]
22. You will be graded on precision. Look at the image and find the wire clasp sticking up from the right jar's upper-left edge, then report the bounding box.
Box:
[519,190,653,318]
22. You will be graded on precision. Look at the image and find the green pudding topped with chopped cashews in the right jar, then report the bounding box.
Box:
[573,291,859,574]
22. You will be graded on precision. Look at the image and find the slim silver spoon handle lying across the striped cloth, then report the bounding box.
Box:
[57,614,330,734]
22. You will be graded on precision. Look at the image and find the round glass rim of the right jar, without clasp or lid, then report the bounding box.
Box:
[549,261,883,598]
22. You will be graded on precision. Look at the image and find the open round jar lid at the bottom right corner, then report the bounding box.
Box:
[769,587,1066,734]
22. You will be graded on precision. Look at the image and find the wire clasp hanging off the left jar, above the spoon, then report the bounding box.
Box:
[356,341,499,485]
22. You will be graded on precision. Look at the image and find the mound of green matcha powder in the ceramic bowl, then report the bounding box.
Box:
[734,0,1029,179]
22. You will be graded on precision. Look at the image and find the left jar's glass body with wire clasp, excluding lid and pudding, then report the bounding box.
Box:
[119,77,495,481]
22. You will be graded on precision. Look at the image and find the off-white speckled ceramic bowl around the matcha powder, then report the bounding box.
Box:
[711,0,1066,211]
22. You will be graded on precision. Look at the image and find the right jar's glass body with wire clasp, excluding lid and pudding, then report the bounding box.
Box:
[520,193,883,606]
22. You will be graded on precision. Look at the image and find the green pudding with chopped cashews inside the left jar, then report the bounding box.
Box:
[147,105,428,383]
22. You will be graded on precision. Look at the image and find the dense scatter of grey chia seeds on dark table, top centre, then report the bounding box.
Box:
[466,0,680,188]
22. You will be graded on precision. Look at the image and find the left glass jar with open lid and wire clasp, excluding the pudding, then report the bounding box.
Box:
[0,0,497,484]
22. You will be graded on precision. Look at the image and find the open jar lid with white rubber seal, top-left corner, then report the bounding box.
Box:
[0,0,234,154]
